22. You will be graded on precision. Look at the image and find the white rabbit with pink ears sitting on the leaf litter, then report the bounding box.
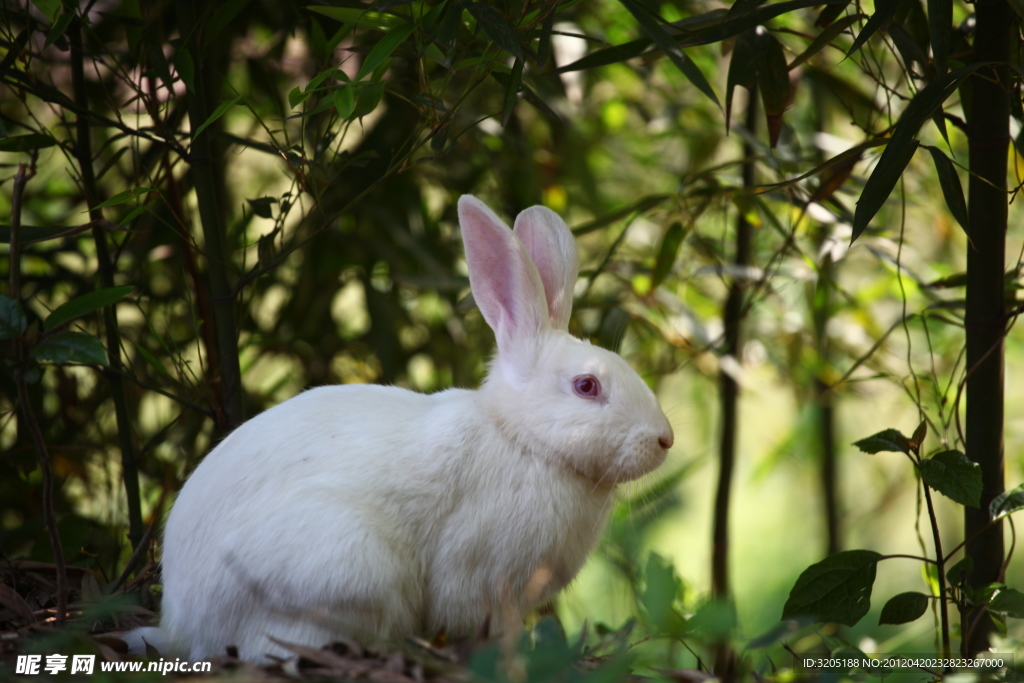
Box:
[142,196,673,660]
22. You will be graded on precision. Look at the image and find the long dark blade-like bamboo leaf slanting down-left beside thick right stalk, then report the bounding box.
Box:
[851,63,981,243]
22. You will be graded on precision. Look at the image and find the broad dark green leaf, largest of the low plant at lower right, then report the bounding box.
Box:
[782,550,882,626]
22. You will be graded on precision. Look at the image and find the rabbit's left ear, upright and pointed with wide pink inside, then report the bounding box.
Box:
[459,195,550,358]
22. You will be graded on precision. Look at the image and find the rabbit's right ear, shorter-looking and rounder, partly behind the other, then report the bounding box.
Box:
[515,206,580,330]
